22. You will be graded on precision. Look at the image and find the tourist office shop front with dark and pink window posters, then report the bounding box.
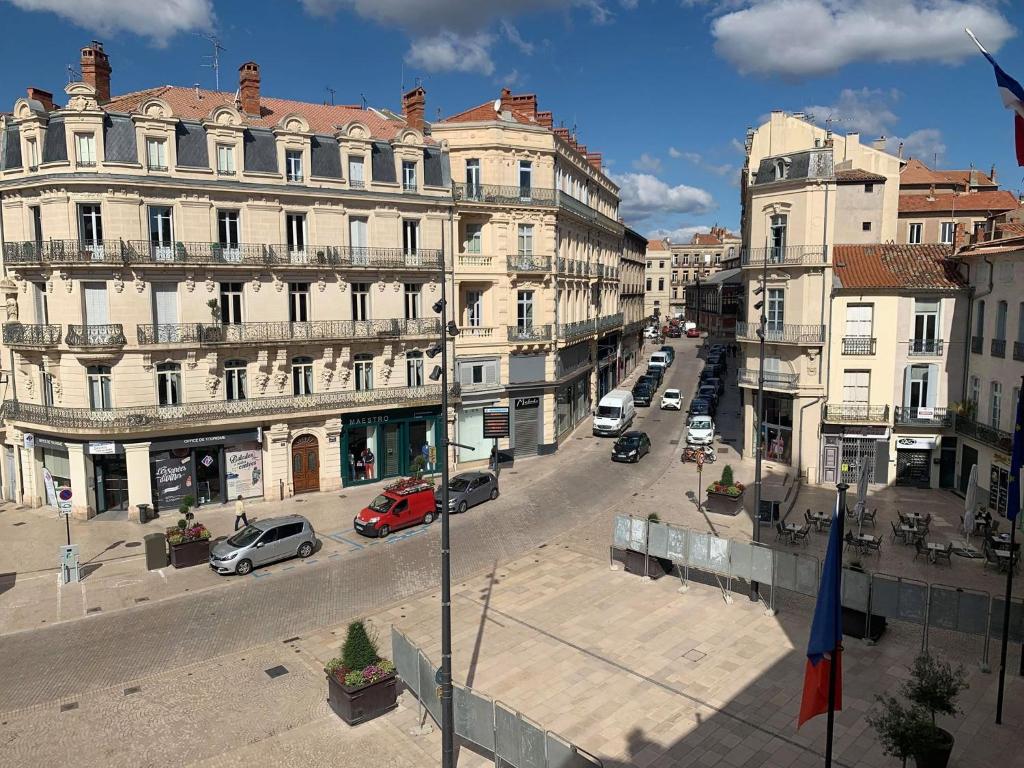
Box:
[151,427,263,512]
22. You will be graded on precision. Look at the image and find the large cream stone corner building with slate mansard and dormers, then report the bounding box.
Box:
[0,44,453,517]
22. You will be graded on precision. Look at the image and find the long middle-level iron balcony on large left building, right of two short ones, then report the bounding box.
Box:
[136,317,440,346]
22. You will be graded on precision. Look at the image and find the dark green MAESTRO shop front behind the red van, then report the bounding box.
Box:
[341,406,442,485]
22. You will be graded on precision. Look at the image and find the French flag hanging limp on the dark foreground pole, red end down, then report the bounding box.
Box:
[797,497,844,729]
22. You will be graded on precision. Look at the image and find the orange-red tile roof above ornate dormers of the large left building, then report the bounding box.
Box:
[103,85,406,140]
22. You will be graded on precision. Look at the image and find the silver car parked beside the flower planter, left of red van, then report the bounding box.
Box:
[209,515,316,575]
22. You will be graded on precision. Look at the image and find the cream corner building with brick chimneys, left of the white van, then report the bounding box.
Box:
[431,89,624,462]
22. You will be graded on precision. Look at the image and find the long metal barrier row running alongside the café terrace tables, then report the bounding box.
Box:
[611,515,1024,669]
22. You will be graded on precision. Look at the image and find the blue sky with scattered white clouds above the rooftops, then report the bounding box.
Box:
[0,0,1024,240]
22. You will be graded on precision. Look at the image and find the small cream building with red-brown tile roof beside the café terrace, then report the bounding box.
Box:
[819,244,968,488]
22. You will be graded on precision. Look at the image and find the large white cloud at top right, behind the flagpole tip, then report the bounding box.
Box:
[712,0,1016,78]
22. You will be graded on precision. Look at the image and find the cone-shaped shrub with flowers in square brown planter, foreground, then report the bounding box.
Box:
[324,622,398,725]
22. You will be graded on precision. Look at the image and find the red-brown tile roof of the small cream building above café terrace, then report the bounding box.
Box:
[833,243,967,289]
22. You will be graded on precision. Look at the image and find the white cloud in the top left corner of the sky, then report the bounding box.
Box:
[7,0,214,46]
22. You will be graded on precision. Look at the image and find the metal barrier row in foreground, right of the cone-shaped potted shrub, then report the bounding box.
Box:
[391,626,598,768]
